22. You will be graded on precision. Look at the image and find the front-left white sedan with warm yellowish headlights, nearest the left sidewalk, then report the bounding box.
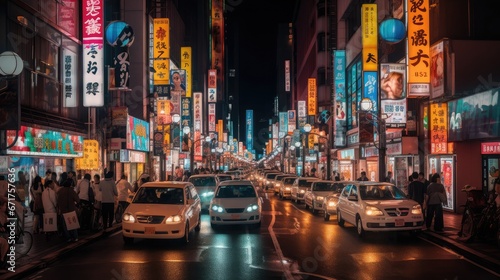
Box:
[122,182,201,244]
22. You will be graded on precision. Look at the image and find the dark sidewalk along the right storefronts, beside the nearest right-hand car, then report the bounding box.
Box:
[422,211,500,271]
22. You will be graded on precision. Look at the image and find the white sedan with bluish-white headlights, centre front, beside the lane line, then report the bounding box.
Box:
[209,180,262,228]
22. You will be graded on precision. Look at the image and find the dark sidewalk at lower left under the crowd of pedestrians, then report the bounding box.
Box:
[0,213,121,279]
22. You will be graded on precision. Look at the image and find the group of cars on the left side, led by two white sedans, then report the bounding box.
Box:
[122,170,262,244]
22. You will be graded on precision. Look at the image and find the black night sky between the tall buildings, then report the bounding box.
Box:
[226,0,295,153]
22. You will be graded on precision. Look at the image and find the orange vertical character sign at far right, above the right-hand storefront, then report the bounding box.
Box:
[430,103,448,154]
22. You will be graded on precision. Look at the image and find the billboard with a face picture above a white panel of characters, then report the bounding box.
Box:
[380,63,406,128]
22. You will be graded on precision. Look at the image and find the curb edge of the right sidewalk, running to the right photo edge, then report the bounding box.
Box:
[422,231,500,271]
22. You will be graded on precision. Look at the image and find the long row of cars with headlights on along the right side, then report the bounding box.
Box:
[252,167,424,236]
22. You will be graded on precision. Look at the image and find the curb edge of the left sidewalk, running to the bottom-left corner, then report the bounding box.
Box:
[0,224,122,279]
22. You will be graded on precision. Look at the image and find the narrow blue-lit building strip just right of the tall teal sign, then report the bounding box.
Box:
[346,57,362,130]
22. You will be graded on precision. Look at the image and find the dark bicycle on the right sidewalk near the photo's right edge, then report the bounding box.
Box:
[458,185,486,242]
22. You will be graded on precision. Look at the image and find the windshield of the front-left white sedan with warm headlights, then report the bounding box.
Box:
[132,187,184,204]
